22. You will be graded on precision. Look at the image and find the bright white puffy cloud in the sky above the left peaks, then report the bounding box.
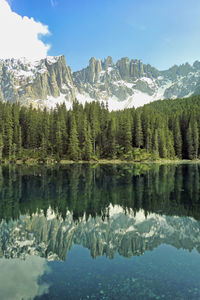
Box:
[0,0,50,60]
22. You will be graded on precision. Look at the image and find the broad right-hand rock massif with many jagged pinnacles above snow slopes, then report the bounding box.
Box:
[73,56,200,109]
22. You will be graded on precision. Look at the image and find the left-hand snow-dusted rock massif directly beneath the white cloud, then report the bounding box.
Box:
[0,56,75,108]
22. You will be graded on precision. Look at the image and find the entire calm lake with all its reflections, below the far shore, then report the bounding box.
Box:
[0,164,200,300]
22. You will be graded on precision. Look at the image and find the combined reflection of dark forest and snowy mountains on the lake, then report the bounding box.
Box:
[0,164,200,260]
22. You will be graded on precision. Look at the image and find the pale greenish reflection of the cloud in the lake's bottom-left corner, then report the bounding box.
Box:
[0,256,49,300]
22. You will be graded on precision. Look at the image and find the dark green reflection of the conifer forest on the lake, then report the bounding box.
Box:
[0,164,200,221]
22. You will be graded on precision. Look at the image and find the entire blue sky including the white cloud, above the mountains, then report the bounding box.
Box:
[0,0,200,71]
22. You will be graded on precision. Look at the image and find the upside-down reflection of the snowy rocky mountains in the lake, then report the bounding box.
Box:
[0,206,200,260]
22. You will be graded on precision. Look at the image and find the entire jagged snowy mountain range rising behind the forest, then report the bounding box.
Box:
[0,55,200,110]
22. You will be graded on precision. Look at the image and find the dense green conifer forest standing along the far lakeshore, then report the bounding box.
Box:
[0,96,200,161]
